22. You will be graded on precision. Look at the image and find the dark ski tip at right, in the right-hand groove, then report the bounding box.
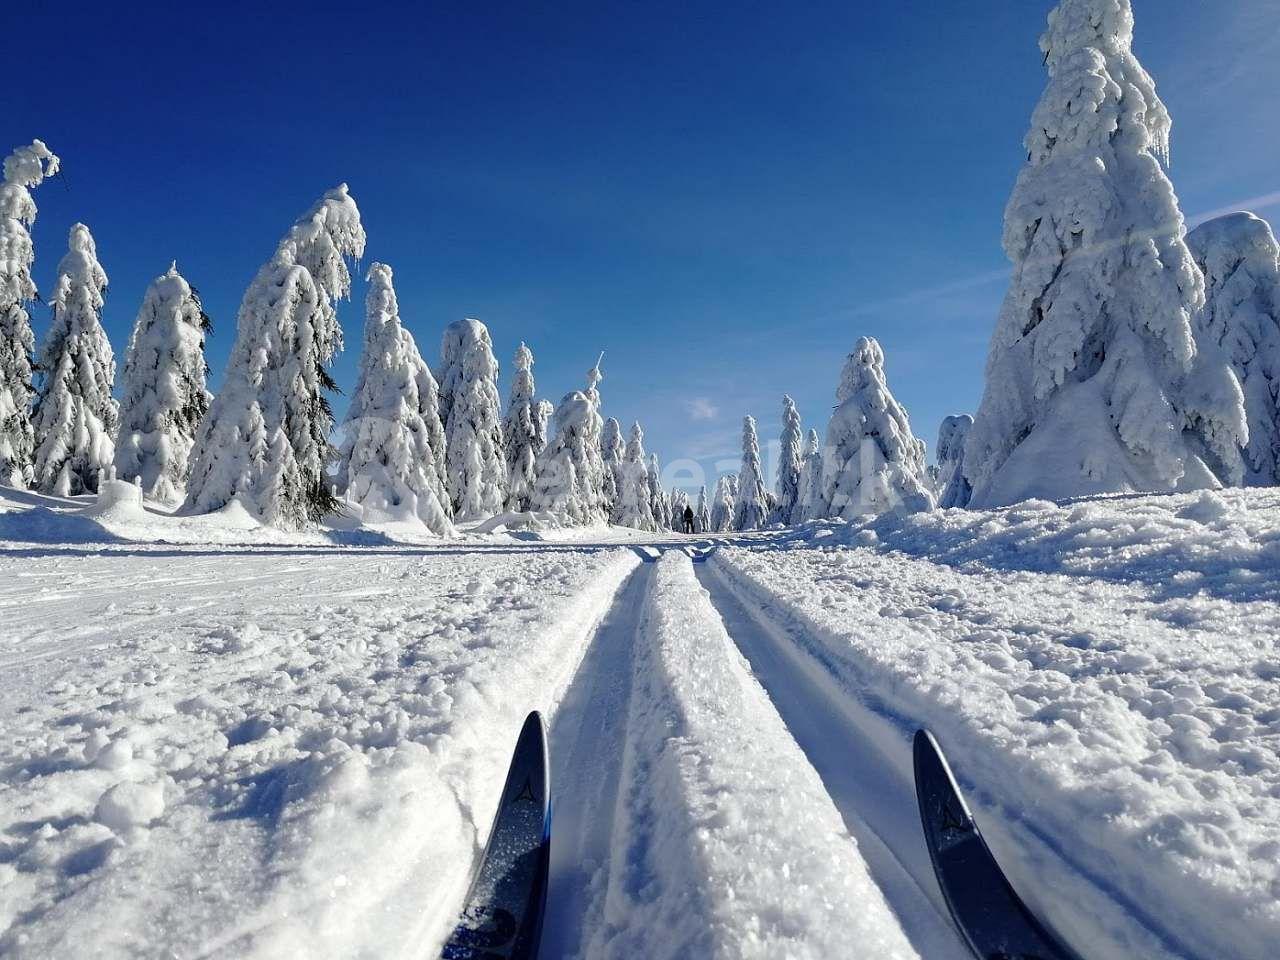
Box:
[915,730,1080,960]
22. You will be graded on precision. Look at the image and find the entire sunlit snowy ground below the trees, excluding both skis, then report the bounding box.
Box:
[0,490,1280,960]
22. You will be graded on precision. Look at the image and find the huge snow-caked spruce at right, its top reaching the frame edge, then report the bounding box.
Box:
[964,0,1245,507]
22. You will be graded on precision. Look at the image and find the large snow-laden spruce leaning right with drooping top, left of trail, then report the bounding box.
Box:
[183,184,365,527]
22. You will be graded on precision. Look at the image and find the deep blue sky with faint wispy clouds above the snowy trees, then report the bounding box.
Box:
[10,0,1280,491]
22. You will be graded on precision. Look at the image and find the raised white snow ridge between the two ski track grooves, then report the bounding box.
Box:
[585,553,918,960]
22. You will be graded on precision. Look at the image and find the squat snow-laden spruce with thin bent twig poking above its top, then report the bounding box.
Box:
[530,390,605,526]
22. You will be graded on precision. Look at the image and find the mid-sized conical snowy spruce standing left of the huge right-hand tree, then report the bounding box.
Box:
[818,337,934,520]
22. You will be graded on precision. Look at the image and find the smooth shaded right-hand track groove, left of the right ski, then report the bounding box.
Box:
[696,561,970,960]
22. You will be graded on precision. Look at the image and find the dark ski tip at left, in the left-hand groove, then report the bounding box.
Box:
[443,710,552,960]
